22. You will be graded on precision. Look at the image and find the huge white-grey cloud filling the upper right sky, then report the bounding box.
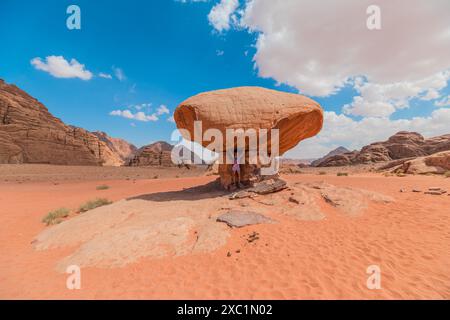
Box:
[241,0,450,97]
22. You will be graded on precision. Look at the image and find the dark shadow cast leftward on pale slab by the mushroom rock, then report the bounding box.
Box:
[126,180,229,202]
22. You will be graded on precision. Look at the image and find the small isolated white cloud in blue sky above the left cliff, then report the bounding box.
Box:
[31,56,92,80]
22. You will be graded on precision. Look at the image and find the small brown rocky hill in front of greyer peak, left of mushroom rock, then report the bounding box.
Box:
[128,141,175,167]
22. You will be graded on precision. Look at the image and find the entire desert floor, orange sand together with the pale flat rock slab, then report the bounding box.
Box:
[0,173,450,299]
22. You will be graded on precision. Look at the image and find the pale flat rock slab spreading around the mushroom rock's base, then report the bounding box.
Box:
[33,182,393,272]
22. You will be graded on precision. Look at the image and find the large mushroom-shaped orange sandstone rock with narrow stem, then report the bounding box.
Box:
[174,87,323,188]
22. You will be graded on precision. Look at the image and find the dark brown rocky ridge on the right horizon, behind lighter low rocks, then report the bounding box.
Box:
[316,131,450,167]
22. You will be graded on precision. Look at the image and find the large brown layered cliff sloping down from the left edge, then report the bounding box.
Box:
[0,79,123,166]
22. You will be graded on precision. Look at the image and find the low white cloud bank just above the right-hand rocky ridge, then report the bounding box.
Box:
[285,108,450,158]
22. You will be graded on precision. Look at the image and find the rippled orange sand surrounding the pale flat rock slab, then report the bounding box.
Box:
[0,168,450,299]
